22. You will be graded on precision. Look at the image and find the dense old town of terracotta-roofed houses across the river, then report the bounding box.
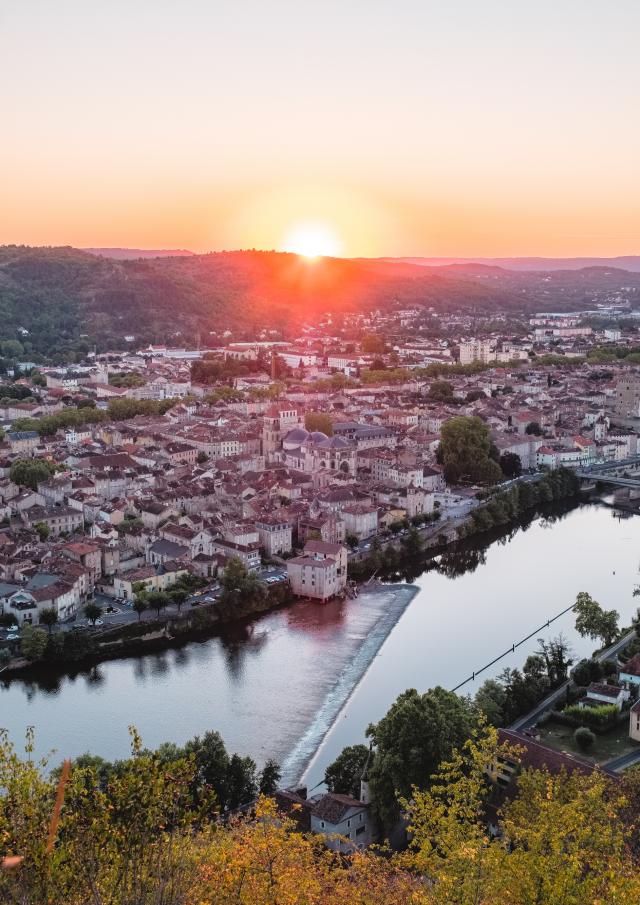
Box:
[0,337,640,622]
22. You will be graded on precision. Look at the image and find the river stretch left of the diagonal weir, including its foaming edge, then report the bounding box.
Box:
[0,585,424,776]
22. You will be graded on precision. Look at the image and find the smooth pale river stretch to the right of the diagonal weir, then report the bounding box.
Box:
[306,506,640,784]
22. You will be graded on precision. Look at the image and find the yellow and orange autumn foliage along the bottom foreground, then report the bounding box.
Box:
[0,730,640,905]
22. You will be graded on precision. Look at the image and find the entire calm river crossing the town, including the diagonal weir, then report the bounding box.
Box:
[0,504,640,785]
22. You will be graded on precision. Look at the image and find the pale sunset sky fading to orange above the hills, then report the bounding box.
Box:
[0,0,640,256]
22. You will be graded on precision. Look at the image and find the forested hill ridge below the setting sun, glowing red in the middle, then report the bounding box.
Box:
[0,246,640,358]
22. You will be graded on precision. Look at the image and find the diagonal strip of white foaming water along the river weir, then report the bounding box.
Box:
[282,585,420,786]
